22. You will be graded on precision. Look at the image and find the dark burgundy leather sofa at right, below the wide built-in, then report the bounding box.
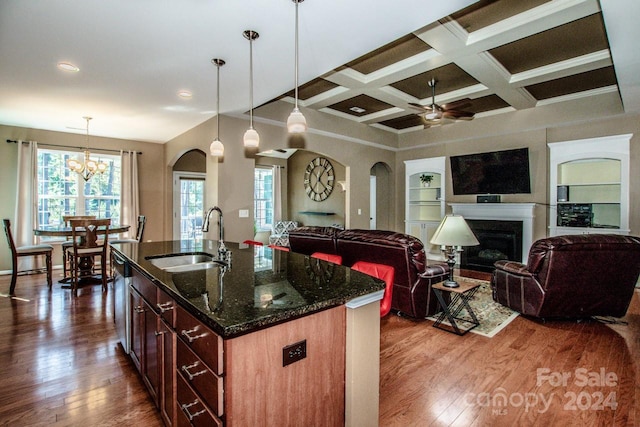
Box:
[491,234,640,318]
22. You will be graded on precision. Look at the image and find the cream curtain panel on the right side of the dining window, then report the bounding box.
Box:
[120,151,140,239]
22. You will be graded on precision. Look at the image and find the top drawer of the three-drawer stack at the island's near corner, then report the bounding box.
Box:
[175,306,223,375]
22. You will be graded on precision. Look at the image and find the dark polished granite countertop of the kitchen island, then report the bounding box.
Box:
[112,240,384,338]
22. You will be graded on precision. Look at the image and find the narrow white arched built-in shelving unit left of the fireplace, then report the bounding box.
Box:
[404,157,445,258]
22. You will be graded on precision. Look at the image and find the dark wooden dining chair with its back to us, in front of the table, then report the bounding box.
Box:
[68,219,111,296]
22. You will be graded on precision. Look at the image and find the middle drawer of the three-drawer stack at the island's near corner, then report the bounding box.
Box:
[176,340,224,416]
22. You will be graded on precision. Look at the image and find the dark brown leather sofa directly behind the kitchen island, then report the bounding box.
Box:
[289,226,449,319]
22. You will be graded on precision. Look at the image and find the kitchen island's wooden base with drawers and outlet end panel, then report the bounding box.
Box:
[122,268,348,427]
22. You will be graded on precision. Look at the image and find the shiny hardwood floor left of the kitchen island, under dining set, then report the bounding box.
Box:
[0,271,162,427]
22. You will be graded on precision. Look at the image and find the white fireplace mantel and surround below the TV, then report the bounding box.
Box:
[449,203,536,263]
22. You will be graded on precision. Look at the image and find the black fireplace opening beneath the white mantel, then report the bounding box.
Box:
[460,219,522,271]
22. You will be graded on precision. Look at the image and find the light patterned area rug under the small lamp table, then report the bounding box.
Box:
[428,277,519,338]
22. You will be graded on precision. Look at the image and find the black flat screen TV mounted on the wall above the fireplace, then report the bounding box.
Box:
[449,148,531,195]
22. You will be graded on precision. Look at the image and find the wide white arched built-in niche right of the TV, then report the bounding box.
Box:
[548,135,631,236]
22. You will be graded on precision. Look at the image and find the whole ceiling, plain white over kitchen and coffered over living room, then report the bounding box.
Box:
[0,0,640,143]
